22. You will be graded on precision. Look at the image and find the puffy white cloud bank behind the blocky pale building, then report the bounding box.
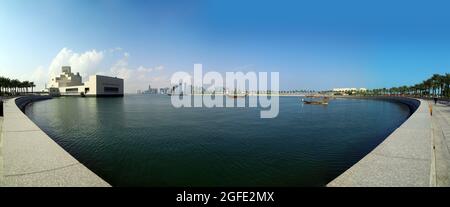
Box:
[29,47,169,93]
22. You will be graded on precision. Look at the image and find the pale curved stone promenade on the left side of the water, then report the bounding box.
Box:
[0,96,110,187]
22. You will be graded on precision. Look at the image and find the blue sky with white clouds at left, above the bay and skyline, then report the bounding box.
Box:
[0,0,450,92]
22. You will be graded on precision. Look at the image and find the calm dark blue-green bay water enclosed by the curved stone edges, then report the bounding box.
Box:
[26,95,409,186]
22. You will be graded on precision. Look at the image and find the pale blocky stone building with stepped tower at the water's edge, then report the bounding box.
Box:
[49,66,123,96]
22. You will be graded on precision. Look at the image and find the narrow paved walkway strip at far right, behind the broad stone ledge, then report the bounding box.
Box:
[429,101,450,186]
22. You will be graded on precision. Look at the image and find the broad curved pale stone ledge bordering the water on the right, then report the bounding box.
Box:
[327,97,434,187]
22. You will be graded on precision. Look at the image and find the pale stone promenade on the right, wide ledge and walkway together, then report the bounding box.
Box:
[327,99,450,187]
